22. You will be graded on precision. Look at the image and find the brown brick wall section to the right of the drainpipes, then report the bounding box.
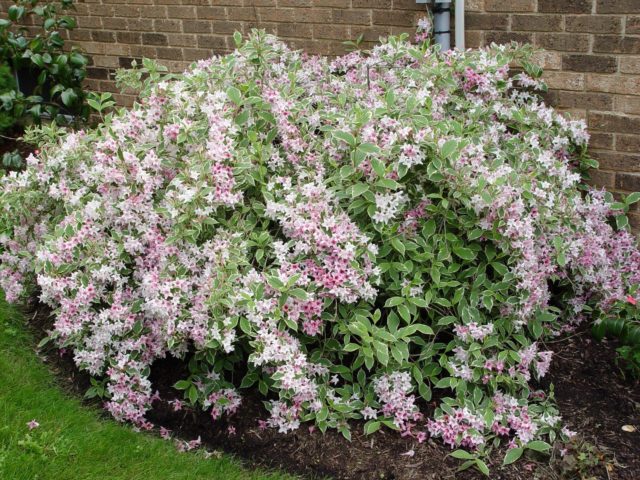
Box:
[465,0,640,228]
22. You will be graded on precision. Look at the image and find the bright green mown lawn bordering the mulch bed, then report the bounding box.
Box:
[0,291,292,480]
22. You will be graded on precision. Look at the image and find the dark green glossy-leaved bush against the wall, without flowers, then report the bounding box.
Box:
[0,0,88,131]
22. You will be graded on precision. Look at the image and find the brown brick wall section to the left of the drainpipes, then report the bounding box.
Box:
[0,0,426,104]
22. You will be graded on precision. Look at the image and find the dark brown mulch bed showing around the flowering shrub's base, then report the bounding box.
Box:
[21,302,640,480]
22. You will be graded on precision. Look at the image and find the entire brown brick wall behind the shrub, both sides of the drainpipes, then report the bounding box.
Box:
[0,0,640,226]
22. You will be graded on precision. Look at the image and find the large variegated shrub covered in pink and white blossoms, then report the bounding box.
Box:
[0,28,640,468]
